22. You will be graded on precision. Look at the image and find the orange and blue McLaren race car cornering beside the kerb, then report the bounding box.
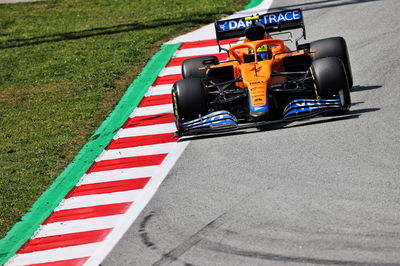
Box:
[172,9,353,136]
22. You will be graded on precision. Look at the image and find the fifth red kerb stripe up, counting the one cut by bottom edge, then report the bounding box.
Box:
[87,153,167,173]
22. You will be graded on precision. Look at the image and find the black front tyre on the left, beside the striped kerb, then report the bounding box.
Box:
[172,78,208,131]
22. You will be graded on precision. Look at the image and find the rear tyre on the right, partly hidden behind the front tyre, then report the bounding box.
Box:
[310,37,353,88]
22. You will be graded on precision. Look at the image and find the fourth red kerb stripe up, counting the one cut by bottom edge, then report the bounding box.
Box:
[65,177,150,199]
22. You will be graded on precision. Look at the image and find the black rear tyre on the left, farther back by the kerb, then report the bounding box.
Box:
[182,56,219,78]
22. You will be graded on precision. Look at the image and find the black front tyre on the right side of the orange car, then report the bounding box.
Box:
[310,57,351,111]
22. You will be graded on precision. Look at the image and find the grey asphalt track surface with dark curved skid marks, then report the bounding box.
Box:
[102,0,400,266]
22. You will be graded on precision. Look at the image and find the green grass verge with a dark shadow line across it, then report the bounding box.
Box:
[0,0,247,238]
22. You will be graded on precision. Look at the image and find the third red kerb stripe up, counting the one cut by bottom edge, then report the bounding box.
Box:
[43,202,132,224]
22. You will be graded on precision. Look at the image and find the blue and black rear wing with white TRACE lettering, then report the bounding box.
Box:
[215,9,306,49]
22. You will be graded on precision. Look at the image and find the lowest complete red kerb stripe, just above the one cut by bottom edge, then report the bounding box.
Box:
[17,228,112,254]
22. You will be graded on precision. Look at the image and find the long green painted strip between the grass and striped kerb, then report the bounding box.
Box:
[0,43,181,265]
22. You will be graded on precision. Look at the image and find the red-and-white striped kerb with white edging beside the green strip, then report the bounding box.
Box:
[1,0,272,266]
